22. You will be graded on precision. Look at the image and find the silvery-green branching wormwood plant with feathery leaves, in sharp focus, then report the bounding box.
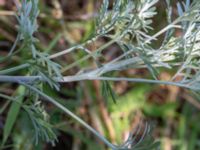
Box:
[0,0,200,150]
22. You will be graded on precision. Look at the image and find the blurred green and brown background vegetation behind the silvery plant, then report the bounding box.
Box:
[0,0,200,150]
